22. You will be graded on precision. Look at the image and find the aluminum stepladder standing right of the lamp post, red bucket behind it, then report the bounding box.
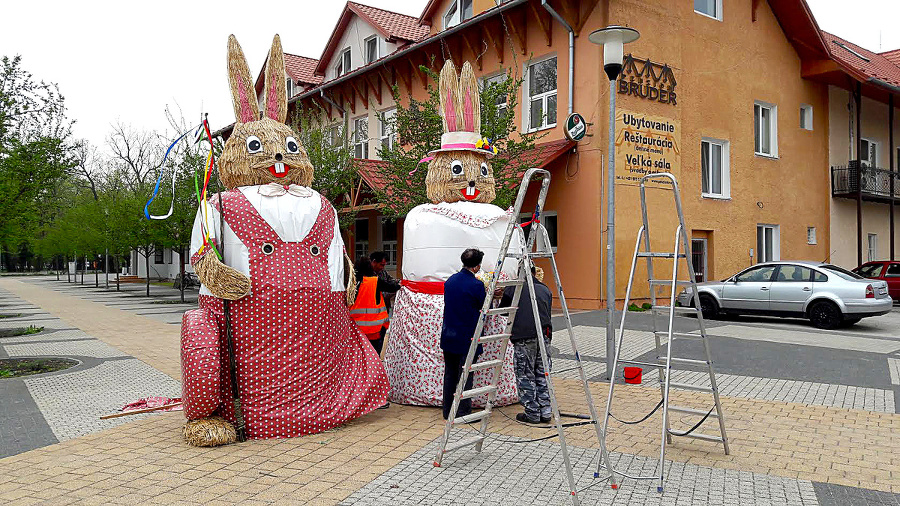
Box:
[602,173,730,492]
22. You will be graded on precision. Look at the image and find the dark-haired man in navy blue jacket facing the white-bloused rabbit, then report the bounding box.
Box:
[441,248,486,420]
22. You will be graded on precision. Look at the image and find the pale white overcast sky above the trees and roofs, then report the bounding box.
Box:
[0,0,900,152]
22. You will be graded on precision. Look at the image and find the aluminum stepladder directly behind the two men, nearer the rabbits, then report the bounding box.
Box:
[434,168,617,506]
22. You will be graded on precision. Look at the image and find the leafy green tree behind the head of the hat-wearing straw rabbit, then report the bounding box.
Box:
[375,66,539,216]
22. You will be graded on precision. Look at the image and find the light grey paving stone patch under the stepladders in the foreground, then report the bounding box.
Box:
[340,434,818,506]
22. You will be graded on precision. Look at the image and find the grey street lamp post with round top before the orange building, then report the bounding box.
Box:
[588,25,641,381]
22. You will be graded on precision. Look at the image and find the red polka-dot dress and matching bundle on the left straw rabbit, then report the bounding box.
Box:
[182,190,388,438]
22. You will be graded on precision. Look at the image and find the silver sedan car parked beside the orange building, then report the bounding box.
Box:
[678,261,893,329]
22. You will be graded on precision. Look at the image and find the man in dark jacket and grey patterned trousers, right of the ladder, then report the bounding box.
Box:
[500,267,553,423]
